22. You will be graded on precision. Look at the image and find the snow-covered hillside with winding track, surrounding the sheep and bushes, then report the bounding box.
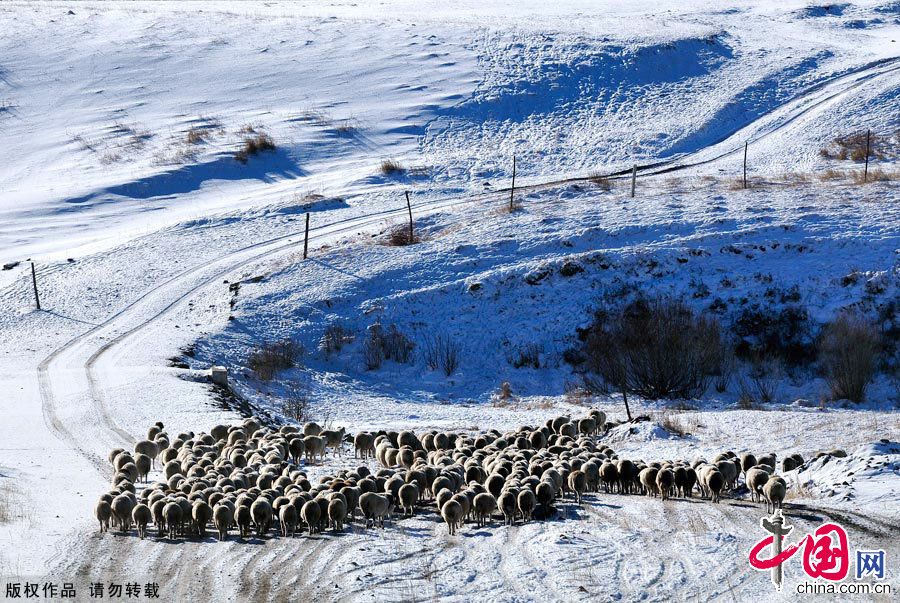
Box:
[0,0,900,601]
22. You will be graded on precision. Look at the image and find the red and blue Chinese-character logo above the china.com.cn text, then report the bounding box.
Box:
[750,509,884,590]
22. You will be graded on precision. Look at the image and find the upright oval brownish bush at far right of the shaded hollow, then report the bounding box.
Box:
[818,313,881,402]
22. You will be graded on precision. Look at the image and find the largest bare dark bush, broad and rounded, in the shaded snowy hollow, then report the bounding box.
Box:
[585,298,724,400]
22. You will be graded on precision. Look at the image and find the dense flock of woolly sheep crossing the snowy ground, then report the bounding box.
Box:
[95,410,803,540]
